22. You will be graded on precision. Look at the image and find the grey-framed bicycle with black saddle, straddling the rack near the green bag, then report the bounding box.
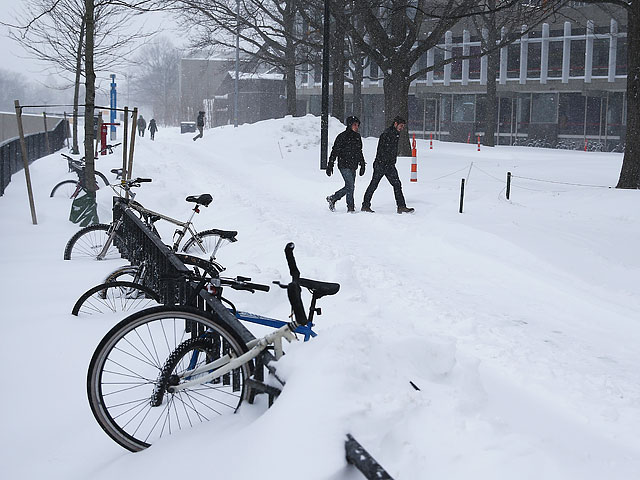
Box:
[64,177,238,260]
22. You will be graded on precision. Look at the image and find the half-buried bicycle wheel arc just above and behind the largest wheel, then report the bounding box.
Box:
[71,281,160,316]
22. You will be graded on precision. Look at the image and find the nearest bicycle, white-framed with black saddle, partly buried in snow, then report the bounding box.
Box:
[87,243,340,452]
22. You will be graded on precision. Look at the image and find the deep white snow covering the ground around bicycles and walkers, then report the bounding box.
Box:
[0,116,640,480]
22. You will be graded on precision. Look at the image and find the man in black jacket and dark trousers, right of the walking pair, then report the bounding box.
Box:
[360,117,415,213]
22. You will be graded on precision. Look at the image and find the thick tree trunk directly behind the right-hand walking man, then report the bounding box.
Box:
[383,68,411,157]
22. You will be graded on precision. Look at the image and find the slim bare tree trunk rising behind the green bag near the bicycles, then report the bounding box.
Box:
[84,0,96,192]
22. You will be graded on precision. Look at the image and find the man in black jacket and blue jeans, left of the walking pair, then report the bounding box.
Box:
[327,115,366,212]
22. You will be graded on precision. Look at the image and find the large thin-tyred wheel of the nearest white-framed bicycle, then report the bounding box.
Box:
[87,306,250,452]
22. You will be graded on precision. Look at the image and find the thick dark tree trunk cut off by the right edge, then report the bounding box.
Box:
[616,0,640,188]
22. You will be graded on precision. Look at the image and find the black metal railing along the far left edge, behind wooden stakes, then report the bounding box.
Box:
[0,120,69,196]
